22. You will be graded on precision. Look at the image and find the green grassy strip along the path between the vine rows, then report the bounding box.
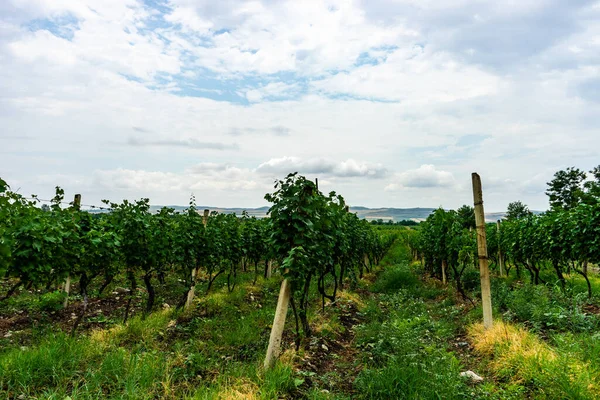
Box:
[356,264,471,399]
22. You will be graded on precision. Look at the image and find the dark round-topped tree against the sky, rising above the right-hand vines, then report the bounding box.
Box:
[546,167,586,210]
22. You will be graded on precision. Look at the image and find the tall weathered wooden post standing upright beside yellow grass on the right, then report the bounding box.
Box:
[472,172,493,329]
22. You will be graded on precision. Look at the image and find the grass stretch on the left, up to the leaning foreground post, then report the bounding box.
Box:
[0,277,296,400]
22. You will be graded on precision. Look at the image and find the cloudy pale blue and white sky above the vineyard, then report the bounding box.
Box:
[0,0,600,212]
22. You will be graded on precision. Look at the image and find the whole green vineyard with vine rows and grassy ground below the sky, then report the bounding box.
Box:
[0,167,600,399]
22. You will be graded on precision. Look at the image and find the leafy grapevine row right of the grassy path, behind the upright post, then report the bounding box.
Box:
[408,167,600,298]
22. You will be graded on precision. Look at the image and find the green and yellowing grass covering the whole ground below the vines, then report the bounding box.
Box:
[0,236,600,400]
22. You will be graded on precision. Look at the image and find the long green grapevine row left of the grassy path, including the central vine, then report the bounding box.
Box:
[0,174,393,333]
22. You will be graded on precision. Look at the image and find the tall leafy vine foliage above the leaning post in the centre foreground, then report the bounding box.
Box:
[265,173,394,336]
